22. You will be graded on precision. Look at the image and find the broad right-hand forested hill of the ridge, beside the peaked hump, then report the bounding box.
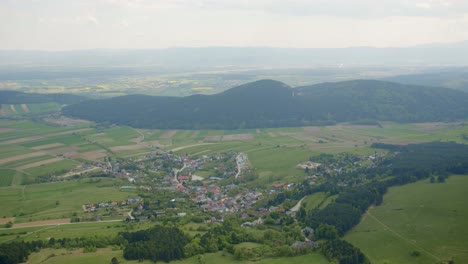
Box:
[295,80,468,122]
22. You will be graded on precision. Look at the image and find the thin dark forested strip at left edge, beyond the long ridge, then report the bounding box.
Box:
[0,91,87,104]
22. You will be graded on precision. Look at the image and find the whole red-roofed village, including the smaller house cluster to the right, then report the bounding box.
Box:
[76,148,385,226]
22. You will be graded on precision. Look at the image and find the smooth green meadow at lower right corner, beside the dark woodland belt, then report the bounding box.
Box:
[345,176,468,263]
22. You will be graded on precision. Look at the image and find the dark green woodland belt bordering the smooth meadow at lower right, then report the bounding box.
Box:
[297,142,468,264]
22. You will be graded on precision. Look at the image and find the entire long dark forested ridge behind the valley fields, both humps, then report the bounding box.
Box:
[63,80,468,129]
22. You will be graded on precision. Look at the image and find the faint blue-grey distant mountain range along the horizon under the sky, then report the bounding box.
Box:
[0,42,468,70]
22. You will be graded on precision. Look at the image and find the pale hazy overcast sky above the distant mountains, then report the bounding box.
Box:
[0,0,468,50]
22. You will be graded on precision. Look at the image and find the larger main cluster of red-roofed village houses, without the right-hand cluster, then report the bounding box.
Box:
[77,151,270,221]
